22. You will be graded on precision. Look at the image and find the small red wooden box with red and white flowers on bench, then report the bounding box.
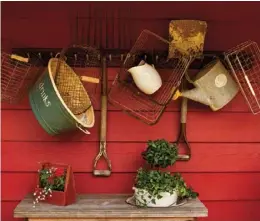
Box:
[33,163,76,207]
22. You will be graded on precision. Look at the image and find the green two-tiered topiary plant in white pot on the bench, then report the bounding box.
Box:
[133,139,198,207]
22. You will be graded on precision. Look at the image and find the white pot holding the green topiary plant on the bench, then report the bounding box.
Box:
[133,187,178,207]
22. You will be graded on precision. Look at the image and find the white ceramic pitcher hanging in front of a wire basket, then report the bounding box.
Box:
[128,60,162,95]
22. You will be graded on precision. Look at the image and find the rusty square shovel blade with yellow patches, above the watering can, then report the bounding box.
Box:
[168,20,207,58]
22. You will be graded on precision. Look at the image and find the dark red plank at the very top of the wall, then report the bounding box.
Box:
[2,2,260,22]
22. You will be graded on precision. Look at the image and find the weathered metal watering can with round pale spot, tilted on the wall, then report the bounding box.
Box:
[173,59,239,111]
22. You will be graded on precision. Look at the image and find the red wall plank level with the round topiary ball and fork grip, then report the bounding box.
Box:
[2,142,260,173]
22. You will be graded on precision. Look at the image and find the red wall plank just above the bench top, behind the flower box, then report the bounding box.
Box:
[2,173,260,200]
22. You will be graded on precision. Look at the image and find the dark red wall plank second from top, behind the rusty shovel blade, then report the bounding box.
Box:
[2,17,260,51]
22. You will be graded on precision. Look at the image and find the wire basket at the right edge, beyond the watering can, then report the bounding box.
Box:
[225,40,260,114]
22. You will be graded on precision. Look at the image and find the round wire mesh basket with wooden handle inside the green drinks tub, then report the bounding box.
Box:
[55,45,100,115]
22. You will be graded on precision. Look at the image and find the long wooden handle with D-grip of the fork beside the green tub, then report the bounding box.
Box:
[93,57,112,176]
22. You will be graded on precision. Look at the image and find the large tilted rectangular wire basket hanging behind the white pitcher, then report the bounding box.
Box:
[108,30,192,125]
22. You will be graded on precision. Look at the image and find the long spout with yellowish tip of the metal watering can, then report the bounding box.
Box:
[173,88,211,106]
